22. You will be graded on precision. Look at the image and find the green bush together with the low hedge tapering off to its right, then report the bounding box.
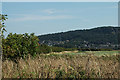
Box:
[2,33,76,59]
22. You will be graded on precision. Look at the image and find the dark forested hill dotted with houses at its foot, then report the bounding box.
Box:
[38,26,120,49]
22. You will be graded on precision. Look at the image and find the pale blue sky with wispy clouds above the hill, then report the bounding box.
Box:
[2,2,118,35]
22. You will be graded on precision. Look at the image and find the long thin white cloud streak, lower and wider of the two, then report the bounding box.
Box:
[9,15,74,22]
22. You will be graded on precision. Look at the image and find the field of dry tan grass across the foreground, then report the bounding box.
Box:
[2,51,120,78]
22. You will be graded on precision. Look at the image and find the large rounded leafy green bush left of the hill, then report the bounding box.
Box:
[2,33,38,58]
